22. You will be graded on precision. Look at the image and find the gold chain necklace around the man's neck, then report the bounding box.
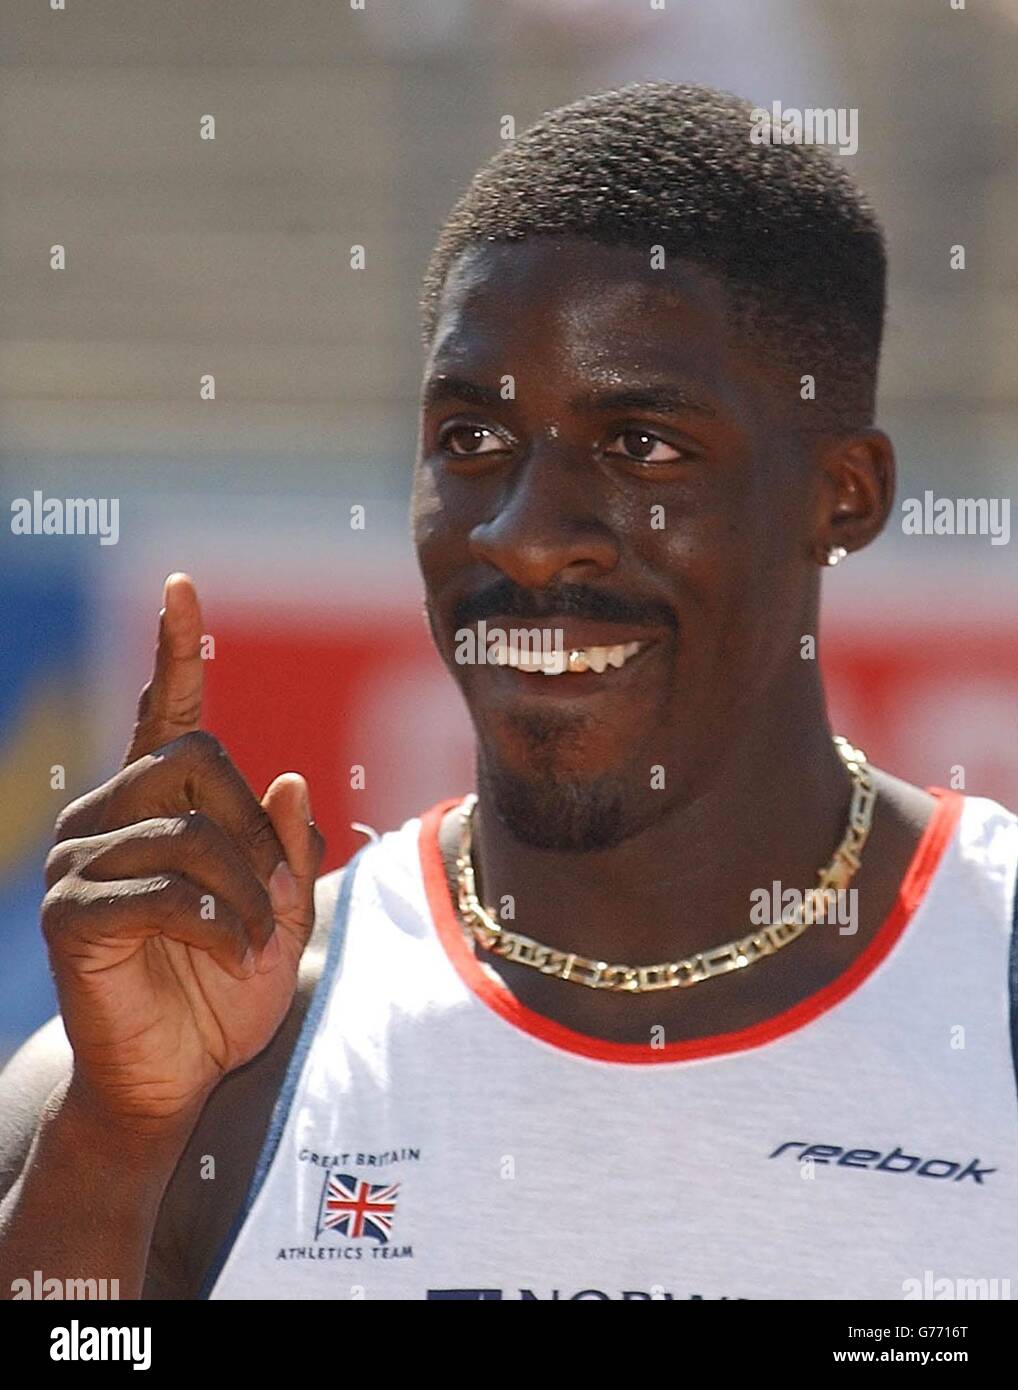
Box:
[456,735,876,994]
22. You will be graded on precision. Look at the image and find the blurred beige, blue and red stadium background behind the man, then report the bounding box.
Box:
[0,0,1018,1059]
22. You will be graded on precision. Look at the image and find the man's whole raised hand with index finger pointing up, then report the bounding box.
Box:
[42,574,324,1130]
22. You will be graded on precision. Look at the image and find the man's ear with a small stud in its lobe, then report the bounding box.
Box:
[812,430,894,564]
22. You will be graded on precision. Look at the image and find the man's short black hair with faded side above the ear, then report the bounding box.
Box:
[420,82,886,430]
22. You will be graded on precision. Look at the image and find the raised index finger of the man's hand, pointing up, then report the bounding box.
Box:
[124,574,204,767]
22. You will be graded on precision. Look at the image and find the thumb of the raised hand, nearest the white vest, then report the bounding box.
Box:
[261,773,325,963]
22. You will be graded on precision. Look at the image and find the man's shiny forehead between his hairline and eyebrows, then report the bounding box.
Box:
[430,236,736,382]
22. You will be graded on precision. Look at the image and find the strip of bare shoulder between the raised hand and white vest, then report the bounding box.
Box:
[142,869,345,1298]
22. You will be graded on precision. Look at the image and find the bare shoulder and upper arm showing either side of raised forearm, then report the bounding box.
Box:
[0,869,345,1298]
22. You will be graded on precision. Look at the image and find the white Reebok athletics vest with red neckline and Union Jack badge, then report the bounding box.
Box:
[203,791,1018,1300]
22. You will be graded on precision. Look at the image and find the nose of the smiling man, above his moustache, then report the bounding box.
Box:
[470,449,619,589]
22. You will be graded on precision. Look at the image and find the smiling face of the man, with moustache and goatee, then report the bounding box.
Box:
[413,238,818,849]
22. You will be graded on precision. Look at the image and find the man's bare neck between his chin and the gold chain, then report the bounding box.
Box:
[473,701,851,965]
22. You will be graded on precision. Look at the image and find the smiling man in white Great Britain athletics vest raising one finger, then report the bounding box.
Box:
[0,83,1018,1298]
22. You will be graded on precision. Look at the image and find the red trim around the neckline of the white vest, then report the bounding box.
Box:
[420,787,964,1063]
